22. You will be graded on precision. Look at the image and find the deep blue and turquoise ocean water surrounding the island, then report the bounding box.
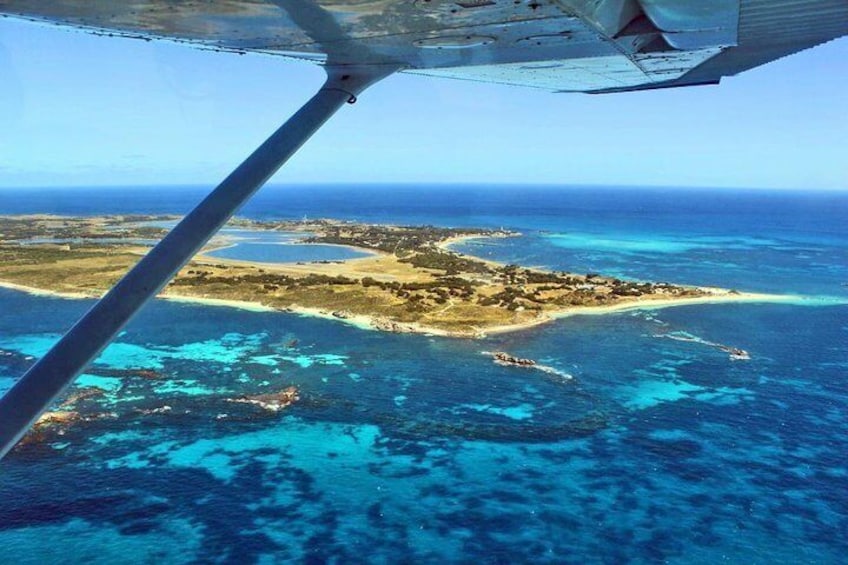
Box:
[0,186,848,563]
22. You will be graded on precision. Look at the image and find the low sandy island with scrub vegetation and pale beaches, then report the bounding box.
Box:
[0,215,779,337]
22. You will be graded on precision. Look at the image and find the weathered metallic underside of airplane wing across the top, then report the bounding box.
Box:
[0,0,848,92]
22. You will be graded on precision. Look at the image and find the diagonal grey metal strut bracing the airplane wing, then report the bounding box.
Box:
[0,65,397,458]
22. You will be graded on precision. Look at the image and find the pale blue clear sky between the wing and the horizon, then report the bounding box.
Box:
[0,18,848,190]
